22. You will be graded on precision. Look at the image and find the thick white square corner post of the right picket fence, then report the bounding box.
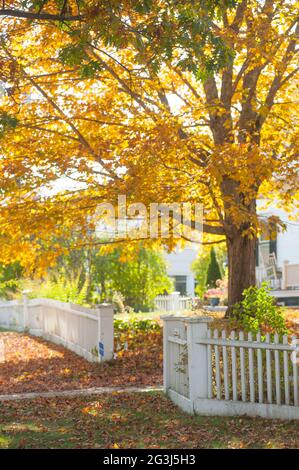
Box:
[186,317,213,406]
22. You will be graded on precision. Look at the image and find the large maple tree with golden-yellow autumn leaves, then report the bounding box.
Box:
[0,0,299,312]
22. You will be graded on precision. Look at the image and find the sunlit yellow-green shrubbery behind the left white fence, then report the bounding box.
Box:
[18,241,173,312]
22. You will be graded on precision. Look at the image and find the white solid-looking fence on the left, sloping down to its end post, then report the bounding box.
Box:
[0,296,114,362]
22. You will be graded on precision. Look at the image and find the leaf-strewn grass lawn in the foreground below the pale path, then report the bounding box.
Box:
[0,392,299,449]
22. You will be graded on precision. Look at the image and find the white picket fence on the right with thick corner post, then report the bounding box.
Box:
[162,316,299,419]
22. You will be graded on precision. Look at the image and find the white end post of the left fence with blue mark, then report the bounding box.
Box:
[96,304,114,361]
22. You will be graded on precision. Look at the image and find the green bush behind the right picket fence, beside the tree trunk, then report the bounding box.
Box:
[233,283,288,334]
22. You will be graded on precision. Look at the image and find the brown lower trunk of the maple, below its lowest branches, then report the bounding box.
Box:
[226,230,256,316]
